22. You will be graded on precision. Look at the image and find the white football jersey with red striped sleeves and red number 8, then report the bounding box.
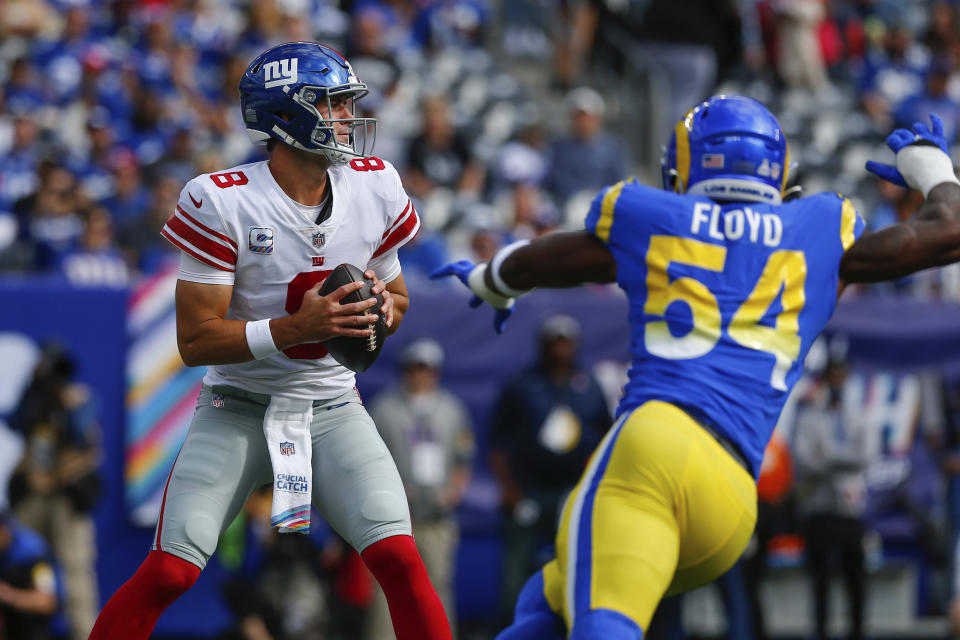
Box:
[161,157,420,399]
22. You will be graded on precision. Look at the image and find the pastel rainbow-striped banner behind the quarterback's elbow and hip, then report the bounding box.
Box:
[124,267,205,527]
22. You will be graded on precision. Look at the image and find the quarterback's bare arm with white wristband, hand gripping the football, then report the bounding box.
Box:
[176,280,377,367]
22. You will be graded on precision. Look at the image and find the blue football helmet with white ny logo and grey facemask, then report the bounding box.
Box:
[240,42,377,164]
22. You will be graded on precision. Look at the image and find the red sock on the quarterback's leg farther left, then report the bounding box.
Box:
[90,551,200,640]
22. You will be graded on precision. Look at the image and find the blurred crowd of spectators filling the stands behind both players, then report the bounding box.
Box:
[0,0,960,296]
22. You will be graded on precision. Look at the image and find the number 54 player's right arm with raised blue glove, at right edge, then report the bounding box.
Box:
[840,115,960,286]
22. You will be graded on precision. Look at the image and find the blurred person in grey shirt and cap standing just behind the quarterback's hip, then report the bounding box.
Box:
[367,338,474,640]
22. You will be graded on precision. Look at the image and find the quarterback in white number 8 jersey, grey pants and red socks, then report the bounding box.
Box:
[91,42,451,640]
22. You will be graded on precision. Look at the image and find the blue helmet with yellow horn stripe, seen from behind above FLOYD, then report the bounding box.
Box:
[660,95,790,204]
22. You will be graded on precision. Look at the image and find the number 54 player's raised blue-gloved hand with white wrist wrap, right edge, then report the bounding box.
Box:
[867,113,957,196]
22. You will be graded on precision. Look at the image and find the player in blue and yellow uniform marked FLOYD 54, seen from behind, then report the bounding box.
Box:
[435,96,960,640]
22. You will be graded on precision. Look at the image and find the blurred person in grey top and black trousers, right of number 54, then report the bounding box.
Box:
[794,354,873,640]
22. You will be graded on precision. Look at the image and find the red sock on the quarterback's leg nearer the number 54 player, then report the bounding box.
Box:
[361,536,452,640]
